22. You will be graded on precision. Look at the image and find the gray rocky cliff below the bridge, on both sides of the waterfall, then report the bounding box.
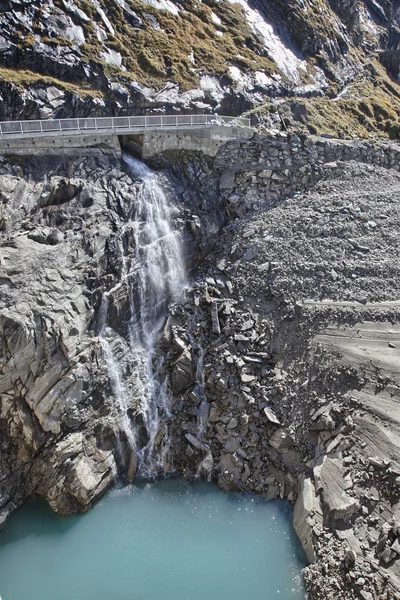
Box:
[0,134,400,600]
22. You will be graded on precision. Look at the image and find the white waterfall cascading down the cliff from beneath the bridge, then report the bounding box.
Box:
[100,155,186,474]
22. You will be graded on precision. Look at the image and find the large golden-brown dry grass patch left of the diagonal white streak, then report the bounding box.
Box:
[75,0,277,90]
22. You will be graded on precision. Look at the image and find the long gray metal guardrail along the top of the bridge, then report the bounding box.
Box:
[0,115,250,137]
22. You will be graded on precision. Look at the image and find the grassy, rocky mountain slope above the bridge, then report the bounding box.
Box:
[0,0,400,137]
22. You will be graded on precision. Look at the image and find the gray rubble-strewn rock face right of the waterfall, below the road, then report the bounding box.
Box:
[159,136,400,600]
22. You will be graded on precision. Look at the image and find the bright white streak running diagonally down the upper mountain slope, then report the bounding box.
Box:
[228,0,306,83]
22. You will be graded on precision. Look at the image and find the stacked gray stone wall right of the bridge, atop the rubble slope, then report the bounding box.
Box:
[214,133,400,216]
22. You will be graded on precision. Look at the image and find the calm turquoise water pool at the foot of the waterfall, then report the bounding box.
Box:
[0,480,304,600]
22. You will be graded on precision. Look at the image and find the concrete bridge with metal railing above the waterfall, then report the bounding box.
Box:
[0,115,253,158]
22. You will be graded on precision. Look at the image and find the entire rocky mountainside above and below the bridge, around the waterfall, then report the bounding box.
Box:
[0,0,400,600]
